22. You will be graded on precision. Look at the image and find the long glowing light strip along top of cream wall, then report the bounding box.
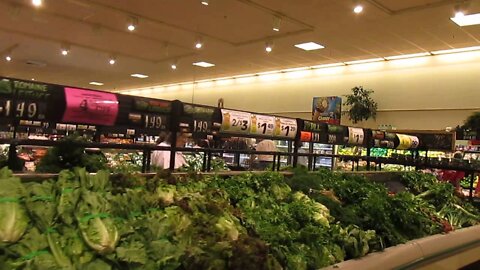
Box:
[124,46,480,93]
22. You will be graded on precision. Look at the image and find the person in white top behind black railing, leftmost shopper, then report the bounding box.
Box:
[152,133,188,169]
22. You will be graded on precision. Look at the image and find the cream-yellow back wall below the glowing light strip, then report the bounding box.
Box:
[125,52,480,129]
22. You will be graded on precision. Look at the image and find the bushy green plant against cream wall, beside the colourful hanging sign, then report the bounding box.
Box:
[344,86,378,124]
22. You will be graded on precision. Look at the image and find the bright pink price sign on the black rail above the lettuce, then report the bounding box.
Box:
[62,87,118,126]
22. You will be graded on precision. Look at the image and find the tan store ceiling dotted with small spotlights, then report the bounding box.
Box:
[0,0,480,90]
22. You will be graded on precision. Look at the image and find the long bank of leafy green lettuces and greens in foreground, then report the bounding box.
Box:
[0,163,480,269]
